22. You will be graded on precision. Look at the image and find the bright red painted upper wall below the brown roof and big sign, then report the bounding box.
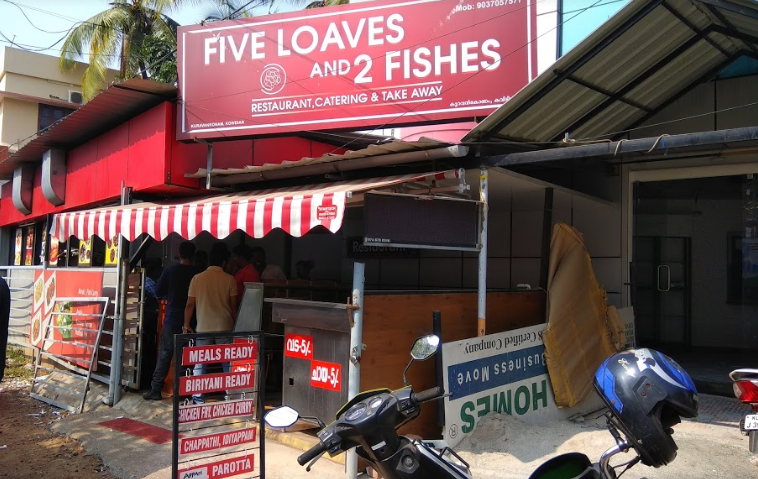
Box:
[0,102,344,226]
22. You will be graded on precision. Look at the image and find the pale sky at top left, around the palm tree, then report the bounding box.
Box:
[0,0,302,61]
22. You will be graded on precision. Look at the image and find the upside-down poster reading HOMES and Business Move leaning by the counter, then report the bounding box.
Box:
[442,324,601,447]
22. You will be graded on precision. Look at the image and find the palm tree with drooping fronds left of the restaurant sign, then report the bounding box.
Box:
[58,0,192,100]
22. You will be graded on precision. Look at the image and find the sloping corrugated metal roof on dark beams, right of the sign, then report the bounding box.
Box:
[463,0,758,142]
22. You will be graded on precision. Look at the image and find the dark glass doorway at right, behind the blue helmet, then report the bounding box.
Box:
[630,174,758,395]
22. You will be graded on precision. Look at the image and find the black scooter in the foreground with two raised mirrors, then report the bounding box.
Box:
[264,335,696,479]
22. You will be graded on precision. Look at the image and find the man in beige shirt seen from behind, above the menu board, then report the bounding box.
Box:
[182,242,237,404]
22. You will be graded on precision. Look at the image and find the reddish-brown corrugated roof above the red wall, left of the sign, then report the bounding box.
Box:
[0,79,177,179]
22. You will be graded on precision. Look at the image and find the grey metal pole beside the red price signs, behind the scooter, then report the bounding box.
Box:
[345,263,366,479]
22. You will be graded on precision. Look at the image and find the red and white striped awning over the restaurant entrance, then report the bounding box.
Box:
[51,170,463,241]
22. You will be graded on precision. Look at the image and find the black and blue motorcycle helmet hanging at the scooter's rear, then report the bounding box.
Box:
[595,349,698,467]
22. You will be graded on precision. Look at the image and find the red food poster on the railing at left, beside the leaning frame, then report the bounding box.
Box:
[30,270,103,370]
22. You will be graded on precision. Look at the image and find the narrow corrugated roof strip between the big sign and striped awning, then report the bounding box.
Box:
[185,138,468,186]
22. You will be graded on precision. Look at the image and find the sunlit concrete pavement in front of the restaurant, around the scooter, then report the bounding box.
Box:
[46,383,758,479]
